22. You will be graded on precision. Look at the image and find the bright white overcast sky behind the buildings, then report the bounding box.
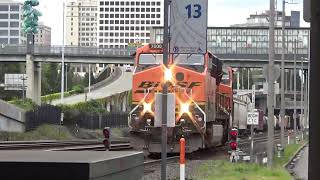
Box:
[17,0,309,45]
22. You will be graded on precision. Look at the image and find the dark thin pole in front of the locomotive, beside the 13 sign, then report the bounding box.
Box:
[161,0,169,180]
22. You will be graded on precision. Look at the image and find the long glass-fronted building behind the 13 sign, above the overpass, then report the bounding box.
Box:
[150,27,310,55]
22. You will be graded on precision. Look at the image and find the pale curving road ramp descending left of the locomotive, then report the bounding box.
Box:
[51,68,132,105]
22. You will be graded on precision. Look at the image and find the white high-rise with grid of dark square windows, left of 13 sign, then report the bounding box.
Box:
[97,0,163,48]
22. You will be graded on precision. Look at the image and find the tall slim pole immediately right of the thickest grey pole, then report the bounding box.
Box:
[280,0,286,147]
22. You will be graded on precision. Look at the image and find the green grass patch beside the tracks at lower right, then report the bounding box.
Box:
[196,141,305,180]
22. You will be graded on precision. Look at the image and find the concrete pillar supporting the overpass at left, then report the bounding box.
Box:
[26,54,41,105]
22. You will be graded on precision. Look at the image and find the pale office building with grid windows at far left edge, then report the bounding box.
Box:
[0,0,27,44]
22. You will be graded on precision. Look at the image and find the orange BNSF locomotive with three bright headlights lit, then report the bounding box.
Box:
[128,44,233,153]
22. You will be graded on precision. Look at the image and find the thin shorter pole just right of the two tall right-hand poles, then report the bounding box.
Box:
[293,39,297,143]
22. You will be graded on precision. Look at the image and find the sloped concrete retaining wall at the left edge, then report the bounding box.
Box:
[0,100,26,132]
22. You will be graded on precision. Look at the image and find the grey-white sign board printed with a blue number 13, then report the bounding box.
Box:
[170,0,208,54]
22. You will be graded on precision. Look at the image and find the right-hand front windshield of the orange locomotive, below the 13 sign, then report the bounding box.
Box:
[173,54,204,72]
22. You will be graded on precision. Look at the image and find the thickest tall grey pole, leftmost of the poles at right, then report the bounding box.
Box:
[267,0,275,168]
